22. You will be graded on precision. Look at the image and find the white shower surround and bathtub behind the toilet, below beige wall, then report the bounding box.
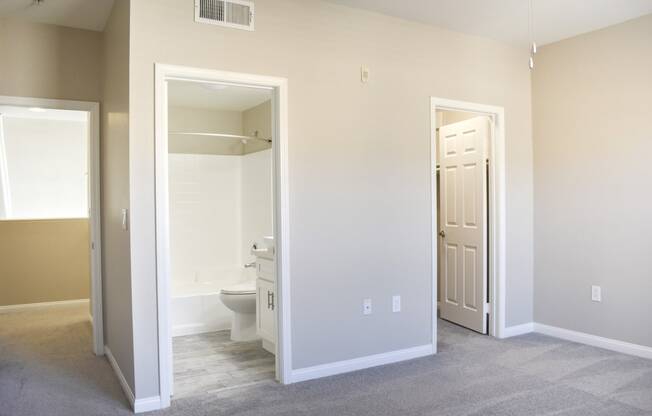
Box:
[169,149,272,336]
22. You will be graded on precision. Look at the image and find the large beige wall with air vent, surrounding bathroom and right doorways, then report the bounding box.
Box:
[130,0,532,397]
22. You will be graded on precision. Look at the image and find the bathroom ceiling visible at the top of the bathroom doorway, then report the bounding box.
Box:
[168,81,272,111]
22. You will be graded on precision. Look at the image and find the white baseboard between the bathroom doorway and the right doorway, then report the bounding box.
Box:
[291,344,434,383]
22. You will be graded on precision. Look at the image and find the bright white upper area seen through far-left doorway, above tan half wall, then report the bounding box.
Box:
[3,116,88,219]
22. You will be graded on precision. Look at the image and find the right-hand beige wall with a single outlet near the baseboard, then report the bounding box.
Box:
[532,15,652,346]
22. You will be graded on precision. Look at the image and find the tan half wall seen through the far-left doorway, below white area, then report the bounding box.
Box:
[0,219,90,306]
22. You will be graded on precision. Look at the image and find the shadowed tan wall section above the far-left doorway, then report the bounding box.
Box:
[0,19,102,101]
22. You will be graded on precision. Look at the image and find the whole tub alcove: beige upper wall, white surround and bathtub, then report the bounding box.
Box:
[169,101,272,336]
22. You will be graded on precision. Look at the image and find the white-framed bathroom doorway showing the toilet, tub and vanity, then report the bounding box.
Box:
[156,66,289,407]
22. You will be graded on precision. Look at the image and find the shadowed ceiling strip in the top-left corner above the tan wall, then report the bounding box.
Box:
[0,0,113,32]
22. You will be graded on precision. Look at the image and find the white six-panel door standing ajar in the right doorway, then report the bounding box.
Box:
[439,116,490,334]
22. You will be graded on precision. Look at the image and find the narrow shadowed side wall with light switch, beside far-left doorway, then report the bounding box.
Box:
[101,0,134,389]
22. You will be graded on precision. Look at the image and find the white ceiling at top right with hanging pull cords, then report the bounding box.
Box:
[327,0,652,45]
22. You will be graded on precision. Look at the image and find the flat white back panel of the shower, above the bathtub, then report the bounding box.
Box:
[169,154,242,290]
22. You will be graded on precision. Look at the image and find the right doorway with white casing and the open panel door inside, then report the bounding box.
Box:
[431,97,505,346]
